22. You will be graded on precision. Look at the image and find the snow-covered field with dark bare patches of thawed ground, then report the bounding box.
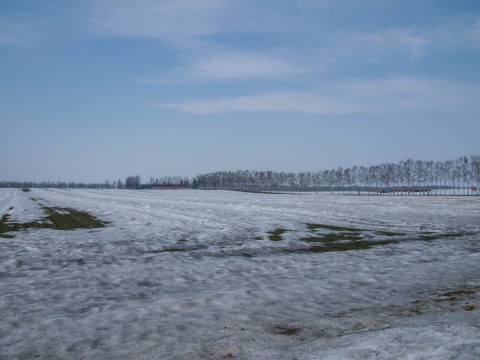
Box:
[0,189,480,359]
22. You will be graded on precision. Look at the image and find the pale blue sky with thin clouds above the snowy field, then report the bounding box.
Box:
[0,0,480,182]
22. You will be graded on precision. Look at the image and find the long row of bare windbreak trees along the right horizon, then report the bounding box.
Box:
[197,155,480,195]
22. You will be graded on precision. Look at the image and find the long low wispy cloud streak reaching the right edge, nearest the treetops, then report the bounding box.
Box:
[157,77,480,115]
